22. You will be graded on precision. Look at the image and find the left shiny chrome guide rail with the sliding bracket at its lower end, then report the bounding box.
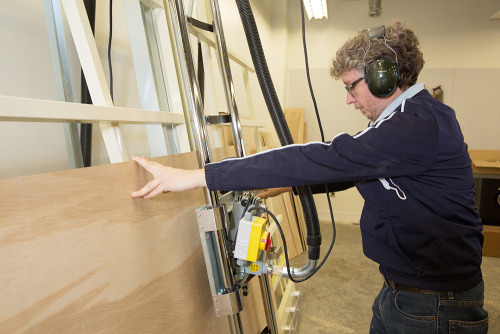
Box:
[167,0,243,334]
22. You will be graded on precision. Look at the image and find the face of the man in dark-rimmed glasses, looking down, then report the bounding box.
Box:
[340,70,392,122]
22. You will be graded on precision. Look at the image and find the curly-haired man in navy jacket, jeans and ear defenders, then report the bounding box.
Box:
[133,20,488,333]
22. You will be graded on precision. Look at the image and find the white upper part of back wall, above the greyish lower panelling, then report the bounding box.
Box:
[289,0,500,68]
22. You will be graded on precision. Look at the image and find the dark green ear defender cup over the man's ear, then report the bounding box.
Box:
[365,58,399,97]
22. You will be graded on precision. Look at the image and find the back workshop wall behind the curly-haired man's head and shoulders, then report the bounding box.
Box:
[287,0,500,221]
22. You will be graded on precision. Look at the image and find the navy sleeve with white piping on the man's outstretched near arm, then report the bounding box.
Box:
[205,103,437,190]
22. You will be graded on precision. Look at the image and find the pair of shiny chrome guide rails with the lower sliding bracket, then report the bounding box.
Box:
[168,0,278,334]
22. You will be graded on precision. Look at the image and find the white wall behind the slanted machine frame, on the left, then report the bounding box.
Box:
[0,0,278,178]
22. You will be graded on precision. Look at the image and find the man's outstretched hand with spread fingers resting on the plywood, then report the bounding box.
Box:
[131,156,207,198]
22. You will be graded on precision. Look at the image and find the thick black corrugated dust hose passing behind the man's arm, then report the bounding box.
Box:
[236,0,321,260]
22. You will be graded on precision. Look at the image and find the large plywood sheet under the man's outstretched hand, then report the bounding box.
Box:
[0,148,265,334]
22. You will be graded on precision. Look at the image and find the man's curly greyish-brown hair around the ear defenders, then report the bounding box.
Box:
[330,19,425,90]
